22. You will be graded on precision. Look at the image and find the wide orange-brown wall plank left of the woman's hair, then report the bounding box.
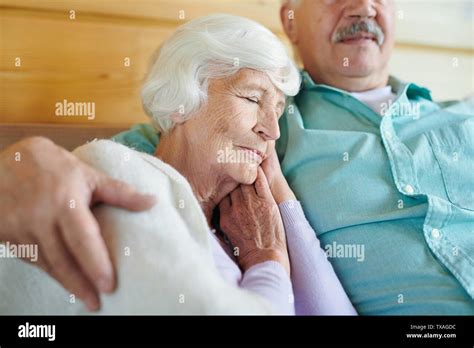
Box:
[0,10,173,123]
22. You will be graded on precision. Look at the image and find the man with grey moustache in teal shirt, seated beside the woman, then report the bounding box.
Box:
[1,0,474,314]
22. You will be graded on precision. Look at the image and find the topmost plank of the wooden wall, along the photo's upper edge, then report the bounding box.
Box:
[0,0,474,53]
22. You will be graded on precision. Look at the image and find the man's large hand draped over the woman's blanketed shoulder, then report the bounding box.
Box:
[0,137,155,310]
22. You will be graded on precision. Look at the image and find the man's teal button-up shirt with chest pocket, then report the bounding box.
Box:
[115,72,474,314]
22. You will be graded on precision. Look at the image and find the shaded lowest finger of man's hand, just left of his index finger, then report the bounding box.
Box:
[40,230,100,311]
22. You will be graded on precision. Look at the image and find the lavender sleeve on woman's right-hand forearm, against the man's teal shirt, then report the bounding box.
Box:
[279,201,357,315]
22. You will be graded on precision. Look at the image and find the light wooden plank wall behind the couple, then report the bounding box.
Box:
[0,0,474,125]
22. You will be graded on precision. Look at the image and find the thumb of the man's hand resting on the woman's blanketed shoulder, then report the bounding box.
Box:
[92,174,156,211]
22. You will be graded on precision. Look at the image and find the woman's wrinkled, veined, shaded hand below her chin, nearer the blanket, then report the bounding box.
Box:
[219,167,290,274]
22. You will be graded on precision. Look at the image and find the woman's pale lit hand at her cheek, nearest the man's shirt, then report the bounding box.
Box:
[262,142,296,204]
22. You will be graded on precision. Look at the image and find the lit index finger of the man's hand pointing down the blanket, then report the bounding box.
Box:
[60,206,115,298]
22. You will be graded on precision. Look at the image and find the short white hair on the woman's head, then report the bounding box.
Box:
[141,14,300,132]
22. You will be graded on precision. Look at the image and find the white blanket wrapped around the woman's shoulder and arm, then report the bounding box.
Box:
[0,140,272,314]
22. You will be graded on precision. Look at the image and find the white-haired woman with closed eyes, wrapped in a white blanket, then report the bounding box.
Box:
[0,15,355,314]
